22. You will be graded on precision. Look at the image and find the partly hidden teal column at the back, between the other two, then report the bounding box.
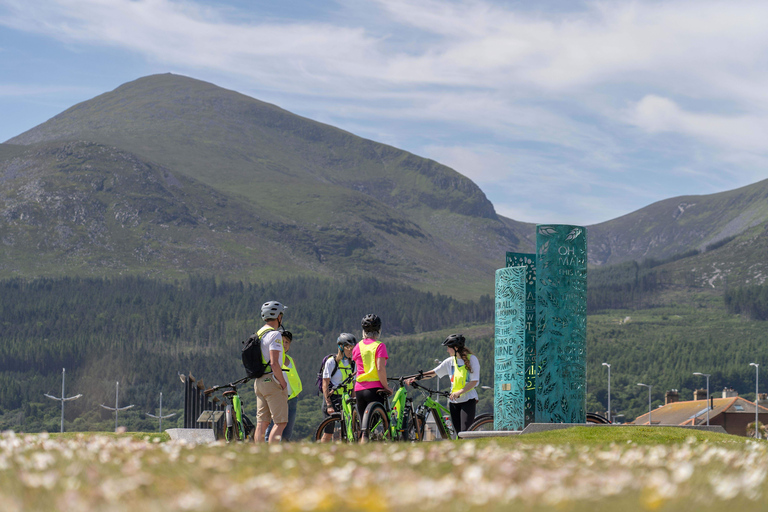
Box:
[506,252,536,426]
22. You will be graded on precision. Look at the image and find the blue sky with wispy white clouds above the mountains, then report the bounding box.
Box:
[0,0,768,225]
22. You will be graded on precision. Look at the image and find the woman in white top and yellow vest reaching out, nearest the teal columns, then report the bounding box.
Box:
[405,334,480,434]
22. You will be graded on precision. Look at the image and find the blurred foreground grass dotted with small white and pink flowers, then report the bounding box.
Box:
[0,428,768,512]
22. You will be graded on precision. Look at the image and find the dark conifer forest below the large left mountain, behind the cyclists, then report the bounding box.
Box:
[0,276,494,433]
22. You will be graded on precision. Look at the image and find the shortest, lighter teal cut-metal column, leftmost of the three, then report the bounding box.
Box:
[493,267,526,430]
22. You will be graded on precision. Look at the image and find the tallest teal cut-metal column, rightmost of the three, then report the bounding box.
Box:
[536,224,587,423]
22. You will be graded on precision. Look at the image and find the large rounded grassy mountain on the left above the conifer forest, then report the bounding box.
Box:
[0,74,534,297]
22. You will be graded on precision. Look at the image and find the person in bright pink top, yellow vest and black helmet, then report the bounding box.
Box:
[352,314,392,442]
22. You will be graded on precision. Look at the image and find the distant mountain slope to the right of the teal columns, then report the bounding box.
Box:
[589,180,768,288]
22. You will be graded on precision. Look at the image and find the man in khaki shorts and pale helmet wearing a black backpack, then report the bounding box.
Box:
[253,300,291,443]
